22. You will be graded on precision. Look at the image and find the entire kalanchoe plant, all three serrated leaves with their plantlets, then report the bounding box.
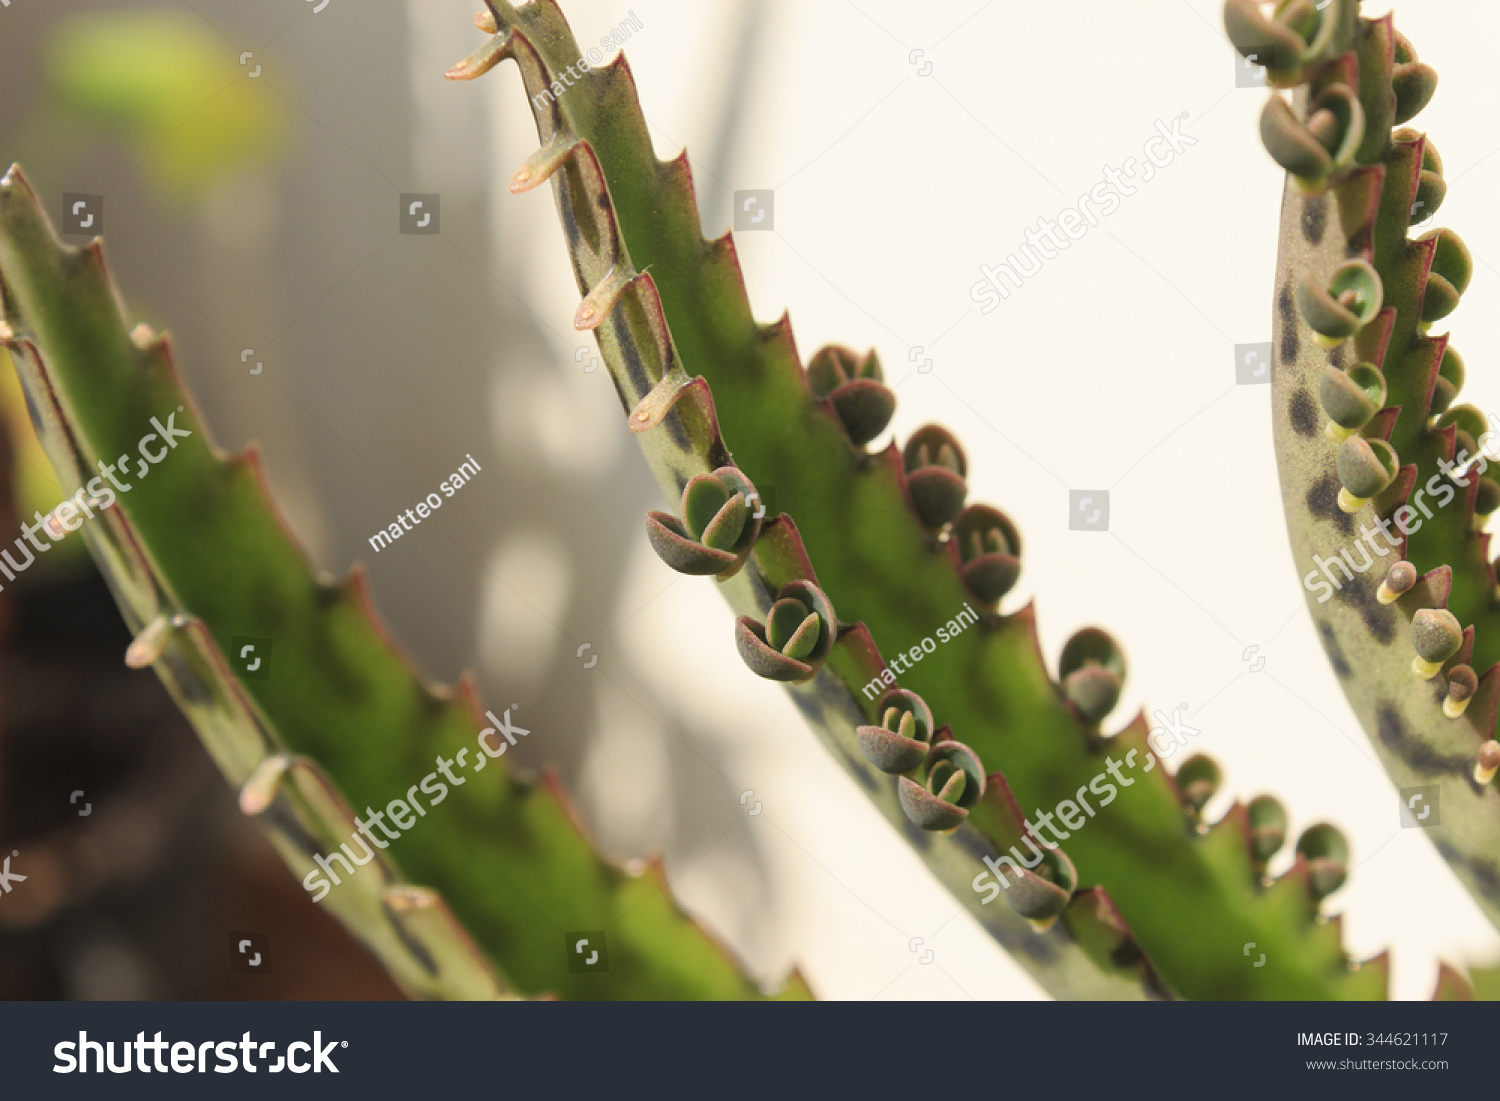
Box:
[14,0,1500,999]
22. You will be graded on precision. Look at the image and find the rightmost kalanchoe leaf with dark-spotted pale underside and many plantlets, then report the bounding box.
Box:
[1224,0,1500,996]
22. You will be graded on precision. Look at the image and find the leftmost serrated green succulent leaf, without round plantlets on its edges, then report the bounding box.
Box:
[0,170,807,999]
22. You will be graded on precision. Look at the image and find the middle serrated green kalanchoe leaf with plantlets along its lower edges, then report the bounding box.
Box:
[449,0,1385,998]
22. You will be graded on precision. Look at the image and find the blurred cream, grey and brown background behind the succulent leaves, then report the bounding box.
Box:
[0,0,1500,999]
